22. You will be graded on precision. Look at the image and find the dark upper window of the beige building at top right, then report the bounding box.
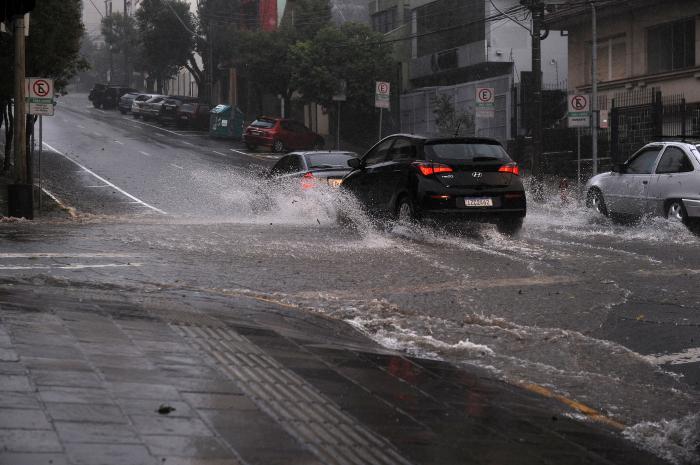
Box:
[647,18,695,74]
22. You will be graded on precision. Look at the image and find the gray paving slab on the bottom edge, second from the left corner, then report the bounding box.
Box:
[66,444,157,465]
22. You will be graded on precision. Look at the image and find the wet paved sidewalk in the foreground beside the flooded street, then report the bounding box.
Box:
[0,283,662,465]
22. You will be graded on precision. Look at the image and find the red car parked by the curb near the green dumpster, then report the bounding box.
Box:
[243,116,324,152]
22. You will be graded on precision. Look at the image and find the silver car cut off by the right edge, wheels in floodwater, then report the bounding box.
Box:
[586,137,700,234]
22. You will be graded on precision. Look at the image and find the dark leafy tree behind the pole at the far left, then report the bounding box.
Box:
[0,0,88,170]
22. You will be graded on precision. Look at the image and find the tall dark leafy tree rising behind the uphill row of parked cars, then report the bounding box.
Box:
[136,0,196,93]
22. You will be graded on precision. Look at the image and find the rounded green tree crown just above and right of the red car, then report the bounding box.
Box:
[290,23,393,113]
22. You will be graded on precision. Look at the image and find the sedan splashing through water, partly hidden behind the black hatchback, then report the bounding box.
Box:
[253,151,357,211]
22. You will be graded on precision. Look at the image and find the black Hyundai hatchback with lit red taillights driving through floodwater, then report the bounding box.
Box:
[342,134,527,235]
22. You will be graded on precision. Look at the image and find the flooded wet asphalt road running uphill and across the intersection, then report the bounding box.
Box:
[0,95,700,460]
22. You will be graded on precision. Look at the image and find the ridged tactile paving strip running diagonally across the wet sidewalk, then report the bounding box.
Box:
[172,325,410,465]
